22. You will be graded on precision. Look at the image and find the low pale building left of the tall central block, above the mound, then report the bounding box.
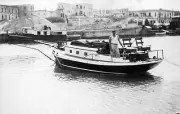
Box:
[32,10,61,18]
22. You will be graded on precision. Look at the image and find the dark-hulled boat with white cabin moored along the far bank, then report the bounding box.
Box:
[8,26,80,42]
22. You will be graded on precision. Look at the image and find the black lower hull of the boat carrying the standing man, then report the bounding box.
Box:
[56,57,160,74]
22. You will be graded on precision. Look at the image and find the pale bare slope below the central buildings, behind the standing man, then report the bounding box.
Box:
[59,17,137,29]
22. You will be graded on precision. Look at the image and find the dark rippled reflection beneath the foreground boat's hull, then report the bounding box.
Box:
[54,65,161,87]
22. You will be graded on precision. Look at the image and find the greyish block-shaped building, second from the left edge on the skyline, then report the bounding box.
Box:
[16,4,34,17]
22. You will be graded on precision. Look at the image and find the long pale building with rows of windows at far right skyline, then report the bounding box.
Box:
[129,9,174,24]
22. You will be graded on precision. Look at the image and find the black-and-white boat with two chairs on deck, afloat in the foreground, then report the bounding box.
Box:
[52,38,163,74]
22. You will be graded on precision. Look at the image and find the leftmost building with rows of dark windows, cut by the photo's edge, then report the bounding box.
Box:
[0,5,18,21]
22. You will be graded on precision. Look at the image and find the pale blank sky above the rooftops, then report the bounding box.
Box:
[0,0,180,10]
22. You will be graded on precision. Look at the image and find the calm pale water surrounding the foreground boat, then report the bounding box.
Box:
[0,36,180,114]
